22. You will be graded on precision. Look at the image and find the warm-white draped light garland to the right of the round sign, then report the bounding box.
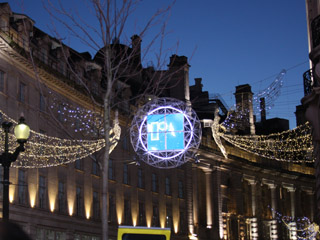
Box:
[216,123,314,162]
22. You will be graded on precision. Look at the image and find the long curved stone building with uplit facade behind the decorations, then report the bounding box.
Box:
[0,3,314,240]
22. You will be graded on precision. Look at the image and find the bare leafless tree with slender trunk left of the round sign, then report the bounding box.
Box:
[38,0,180,240]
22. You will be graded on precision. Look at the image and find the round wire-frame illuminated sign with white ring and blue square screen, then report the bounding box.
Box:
[130,98,201,168]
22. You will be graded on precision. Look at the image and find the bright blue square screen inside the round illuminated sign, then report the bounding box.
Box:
[147,113,184,151]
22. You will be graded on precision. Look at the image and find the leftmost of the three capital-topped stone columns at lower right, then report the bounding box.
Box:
[243,175,259,240]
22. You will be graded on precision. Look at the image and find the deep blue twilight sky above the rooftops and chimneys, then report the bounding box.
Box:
[9,0,309,128]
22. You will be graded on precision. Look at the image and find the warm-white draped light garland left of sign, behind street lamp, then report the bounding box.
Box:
[0,110,121,168]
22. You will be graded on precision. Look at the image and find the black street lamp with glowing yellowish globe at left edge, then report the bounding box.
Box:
[0,117,30,220]
